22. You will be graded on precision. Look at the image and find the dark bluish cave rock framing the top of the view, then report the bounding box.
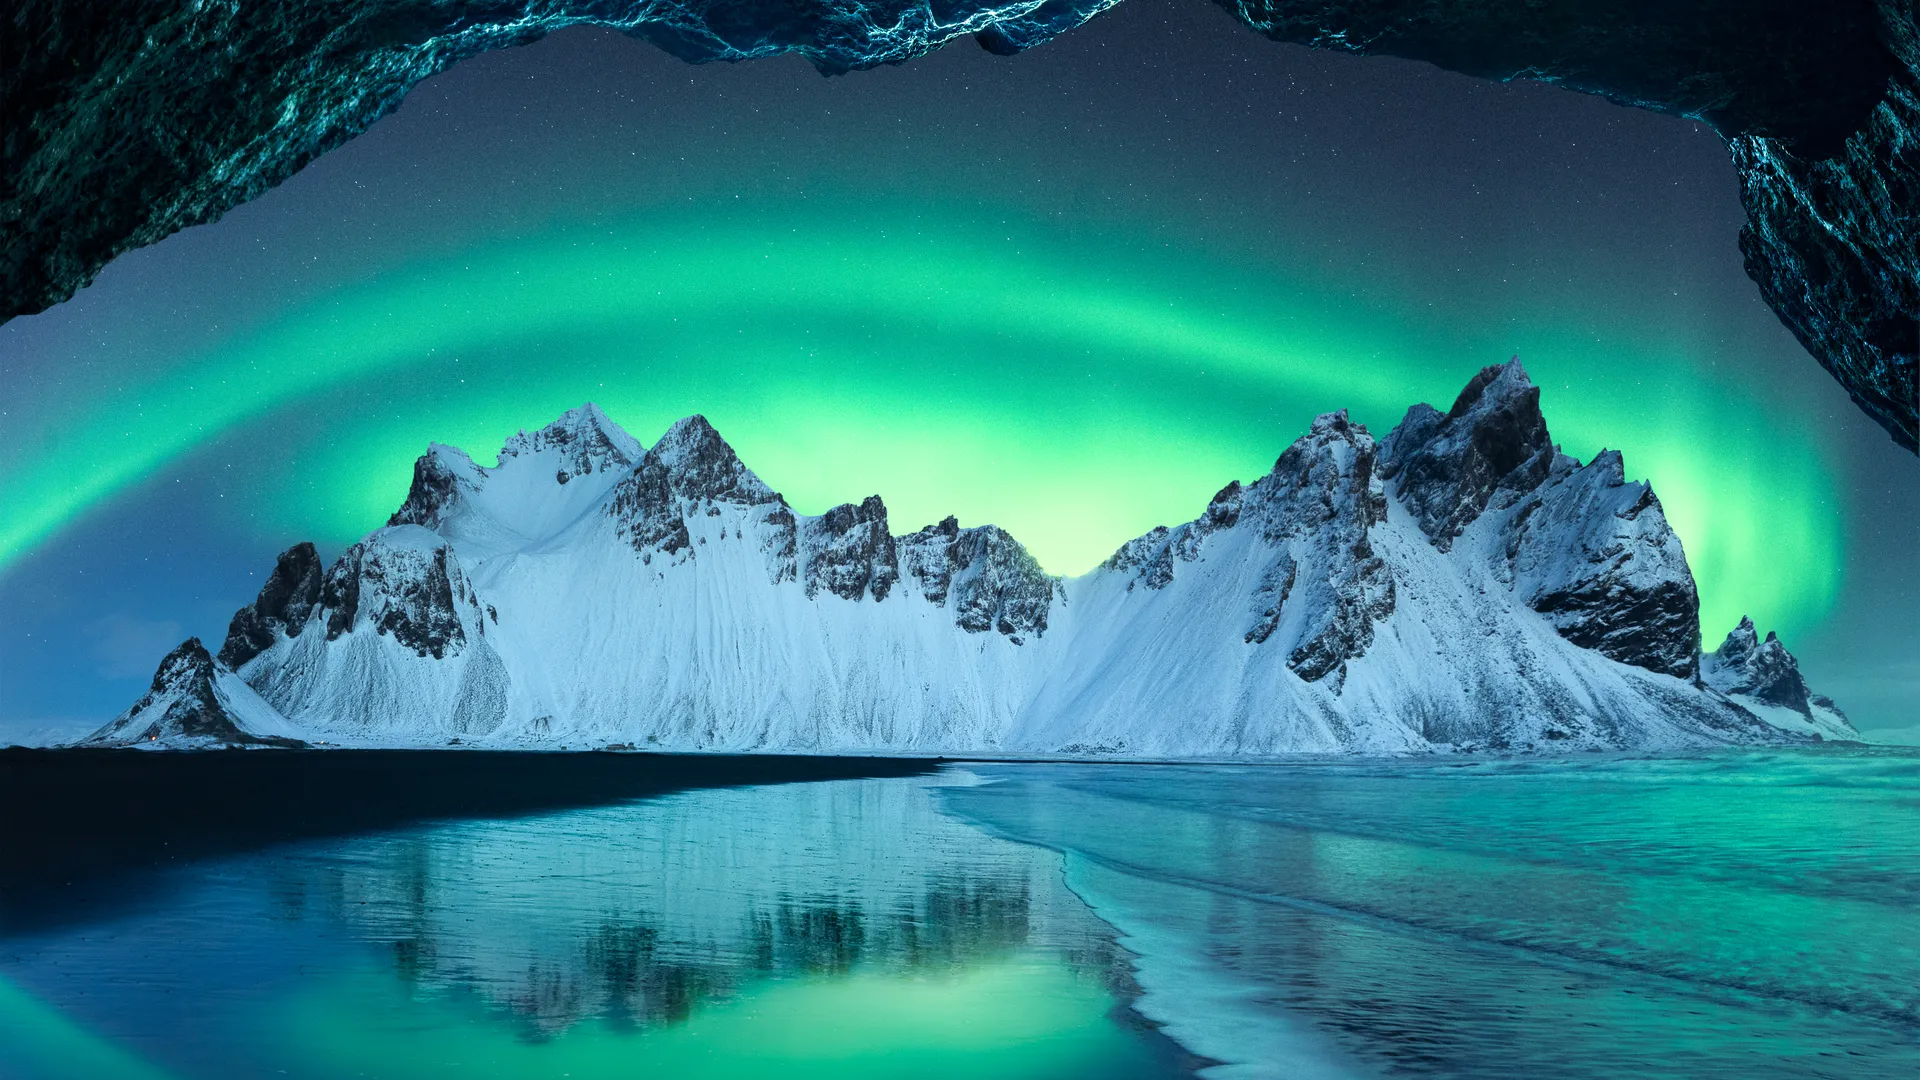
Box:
[0,0,1920,445]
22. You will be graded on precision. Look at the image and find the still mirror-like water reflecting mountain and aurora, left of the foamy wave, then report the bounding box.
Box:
[0,774,1192,1078]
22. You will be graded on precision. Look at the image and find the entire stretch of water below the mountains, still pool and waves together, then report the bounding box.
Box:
[0,751,1920,1080]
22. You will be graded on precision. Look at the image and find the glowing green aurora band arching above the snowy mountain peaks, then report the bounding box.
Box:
[0,204,1843,644]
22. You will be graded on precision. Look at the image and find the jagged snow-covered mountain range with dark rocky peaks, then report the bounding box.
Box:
[88,361,1855,757]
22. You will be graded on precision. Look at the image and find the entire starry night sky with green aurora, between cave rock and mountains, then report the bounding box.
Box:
[0,0,1920,742]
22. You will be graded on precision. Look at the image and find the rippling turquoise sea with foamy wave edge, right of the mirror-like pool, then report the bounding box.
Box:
[943,751,1920,1080]
